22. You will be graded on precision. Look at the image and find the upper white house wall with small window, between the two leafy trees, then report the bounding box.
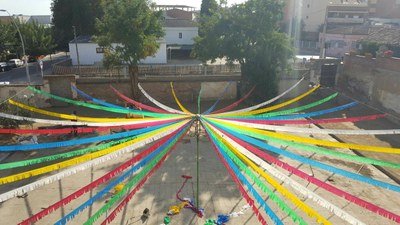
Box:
[164,27,199,45]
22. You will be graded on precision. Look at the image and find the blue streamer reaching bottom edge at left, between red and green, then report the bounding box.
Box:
[55,125,188,225]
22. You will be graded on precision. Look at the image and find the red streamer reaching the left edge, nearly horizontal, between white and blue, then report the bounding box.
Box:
[0,119,180,134]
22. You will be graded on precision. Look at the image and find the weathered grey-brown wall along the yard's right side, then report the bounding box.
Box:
[337,55,400,114]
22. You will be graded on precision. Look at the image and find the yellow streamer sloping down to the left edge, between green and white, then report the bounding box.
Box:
[0,121,187,185]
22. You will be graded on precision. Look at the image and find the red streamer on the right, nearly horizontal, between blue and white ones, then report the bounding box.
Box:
[220,114,387,125]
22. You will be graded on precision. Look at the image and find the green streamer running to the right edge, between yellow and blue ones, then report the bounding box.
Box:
[212,119,400,169]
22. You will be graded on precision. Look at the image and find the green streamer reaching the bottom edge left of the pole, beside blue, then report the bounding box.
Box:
[84,126,189,225]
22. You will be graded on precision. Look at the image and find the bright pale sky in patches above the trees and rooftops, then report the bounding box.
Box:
[0,0,245,16]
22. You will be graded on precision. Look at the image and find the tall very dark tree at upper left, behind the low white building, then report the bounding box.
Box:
[51,0,103,51]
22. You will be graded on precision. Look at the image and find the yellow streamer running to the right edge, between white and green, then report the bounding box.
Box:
[209,118,400,154]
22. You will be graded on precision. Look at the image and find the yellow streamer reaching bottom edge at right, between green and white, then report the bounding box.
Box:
[206,123,331,224]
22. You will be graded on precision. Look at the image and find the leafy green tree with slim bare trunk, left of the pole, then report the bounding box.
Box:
[96,0,164,98]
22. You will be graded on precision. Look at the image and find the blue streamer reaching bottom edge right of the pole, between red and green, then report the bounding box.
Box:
[204,126,283,225]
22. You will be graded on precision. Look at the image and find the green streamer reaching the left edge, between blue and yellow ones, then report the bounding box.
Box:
[0,134,136,170]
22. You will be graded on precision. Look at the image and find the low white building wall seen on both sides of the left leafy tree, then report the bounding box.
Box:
[69,41,167,65]
